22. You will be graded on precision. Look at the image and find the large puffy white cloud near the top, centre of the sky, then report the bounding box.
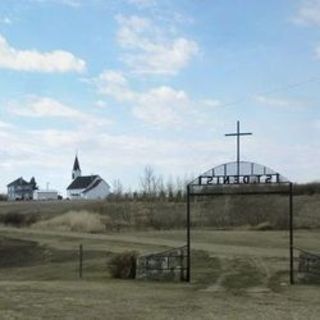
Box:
[117,16,199,75]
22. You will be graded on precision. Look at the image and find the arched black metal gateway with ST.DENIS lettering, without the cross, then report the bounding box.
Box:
[186,161,294,284]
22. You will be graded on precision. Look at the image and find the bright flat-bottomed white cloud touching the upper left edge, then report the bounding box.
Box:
[0,35,86,72]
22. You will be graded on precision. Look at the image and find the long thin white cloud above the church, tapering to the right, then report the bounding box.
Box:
[7,96,110,126]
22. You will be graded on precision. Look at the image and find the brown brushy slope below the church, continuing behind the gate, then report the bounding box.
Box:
[0,193,320,230]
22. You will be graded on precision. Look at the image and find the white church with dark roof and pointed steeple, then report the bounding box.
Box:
[67,155,110,200]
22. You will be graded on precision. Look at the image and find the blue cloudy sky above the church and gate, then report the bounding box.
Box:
[0,0,320,194]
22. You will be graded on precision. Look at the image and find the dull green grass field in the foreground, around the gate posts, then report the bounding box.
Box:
[0,222,320,320]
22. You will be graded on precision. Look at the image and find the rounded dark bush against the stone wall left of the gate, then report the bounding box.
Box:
[108,251,138,279]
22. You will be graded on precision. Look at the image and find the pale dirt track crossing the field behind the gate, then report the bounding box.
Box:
[0,227,288,258]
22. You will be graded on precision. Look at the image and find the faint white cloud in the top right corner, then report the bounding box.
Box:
[294,0,320,26]
